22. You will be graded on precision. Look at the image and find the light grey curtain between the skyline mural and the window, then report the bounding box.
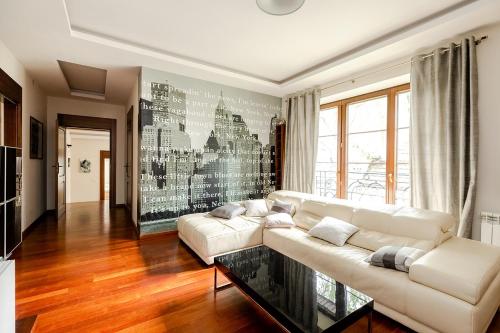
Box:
[283,89,320,193]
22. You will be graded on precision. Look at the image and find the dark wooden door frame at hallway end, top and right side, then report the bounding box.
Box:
[56,113,117,208]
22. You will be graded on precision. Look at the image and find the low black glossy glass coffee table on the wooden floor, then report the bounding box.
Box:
[214,246,373,333]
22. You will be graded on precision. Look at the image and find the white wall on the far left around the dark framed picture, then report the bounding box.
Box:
[0,41,47,230]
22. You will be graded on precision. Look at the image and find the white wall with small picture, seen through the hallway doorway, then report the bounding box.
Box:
[66,132,109,203]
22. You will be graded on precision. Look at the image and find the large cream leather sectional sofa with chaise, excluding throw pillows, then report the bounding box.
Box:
[178,191,500,333]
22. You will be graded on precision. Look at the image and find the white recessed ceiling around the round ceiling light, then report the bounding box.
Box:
[0,0,500,104]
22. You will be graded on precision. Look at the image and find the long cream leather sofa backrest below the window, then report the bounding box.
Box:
[269,191,455,251]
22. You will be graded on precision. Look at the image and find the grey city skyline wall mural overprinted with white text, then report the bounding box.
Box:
[139,68,281,229]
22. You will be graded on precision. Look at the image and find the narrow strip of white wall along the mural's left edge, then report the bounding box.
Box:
[125,77,139,224]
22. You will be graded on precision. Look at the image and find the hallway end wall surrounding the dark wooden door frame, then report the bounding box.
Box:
[46,96,126,209]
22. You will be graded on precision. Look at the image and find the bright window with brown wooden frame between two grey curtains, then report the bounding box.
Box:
[316,85,410,205]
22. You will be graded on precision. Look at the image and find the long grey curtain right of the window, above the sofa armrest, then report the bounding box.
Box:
[410,37,478,238]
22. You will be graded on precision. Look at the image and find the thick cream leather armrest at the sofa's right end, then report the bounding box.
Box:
[409,237,500,304]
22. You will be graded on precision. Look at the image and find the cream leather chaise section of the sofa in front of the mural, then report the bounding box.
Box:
[177,213,263,257]
